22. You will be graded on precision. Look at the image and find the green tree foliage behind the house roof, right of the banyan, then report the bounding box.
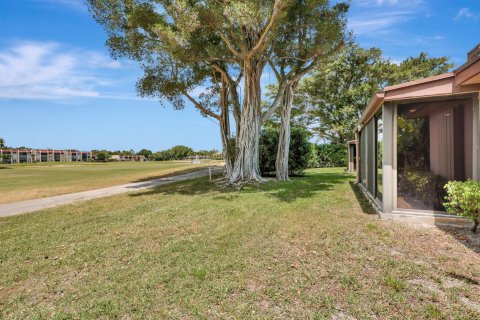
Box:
[296,43,452,144]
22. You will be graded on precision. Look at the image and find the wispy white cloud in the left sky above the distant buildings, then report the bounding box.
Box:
[0,42,125,100]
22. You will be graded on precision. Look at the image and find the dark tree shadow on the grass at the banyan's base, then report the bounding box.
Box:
[130,172,352,202]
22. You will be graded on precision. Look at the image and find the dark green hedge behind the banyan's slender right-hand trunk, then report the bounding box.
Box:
[260,127,310,175]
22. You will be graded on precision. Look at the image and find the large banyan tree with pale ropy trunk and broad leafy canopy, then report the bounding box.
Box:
[88,0,347,183]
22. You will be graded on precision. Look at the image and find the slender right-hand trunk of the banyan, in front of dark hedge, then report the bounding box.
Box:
[275,83,296,180]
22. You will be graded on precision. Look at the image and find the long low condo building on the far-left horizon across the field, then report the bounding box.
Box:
[0,149,93,164]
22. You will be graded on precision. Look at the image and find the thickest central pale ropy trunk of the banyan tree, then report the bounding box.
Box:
[229,64,263,183]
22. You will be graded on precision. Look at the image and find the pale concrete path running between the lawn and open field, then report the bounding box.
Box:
[0,167,222,217]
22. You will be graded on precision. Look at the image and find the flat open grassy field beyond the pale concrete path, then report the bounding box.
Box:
[0,161,218,203]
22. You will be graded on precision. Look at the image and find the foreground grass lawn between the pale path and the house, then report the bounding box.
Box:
[0,169,480,319]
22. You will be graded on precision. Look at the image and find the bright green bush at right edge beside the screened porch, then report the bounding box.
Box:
[443,179,480,232]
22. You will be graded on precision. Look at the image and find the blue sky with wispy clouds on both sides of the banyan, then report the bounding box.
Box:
[0,0,480,151]
